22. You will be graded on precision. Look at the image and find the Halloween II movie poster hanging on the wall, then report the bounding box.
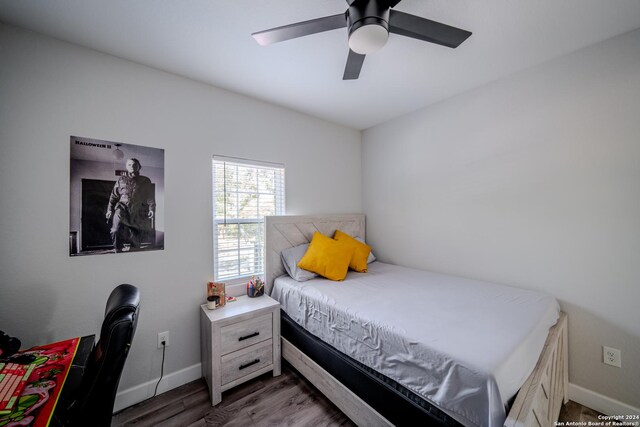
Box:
[69,136,164,256]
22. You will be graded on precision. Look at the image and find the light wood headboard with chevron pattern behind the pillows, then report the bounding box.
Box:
[265,214,366,294]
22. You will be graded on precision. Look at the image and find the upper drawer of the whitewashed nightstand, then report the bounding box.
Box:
[220,313,273,355]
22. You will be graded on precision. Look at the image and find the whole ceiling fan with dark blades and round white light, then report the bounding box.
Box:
[252,0,471,80]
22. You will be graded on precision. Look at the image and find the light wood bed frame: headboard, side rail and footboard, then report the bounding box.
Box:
[265,214,569,427]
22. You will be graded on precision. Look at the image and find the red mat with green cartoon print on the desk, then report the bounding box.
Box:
[0,338,80,427]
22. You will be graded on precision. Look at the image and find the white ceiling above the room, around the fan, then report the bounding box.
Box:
[0,0,640,129]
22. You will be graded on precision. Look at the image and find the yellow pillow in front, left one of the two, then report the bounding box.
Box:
[298,231,354,280]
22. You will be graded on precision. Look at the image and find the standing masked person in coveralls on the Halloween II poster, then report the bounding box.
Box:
[106,158,156,253]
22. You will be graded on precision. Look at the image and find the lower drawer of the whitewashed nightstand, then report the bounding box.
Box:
[221,339,273,386]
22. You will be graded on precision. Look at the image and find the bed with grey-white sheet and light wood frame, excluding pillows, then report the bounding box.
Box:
[265,215,568,427]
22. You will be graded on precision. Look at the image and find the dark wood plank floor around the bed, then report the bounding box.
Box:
[111,361,599,427]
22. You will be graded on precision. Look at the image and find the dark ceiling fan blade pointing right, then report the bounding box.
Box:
[389,9,471,48]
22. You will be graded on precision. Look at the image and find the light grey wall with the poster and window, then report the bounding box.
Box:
[0,25,362,408]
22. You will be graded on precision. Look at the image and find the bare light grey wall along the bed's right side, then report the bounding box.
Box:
[363,31,640,408]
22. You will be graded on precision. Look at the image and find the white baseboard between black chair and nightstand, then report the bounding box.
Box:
[113,363,202,412]
